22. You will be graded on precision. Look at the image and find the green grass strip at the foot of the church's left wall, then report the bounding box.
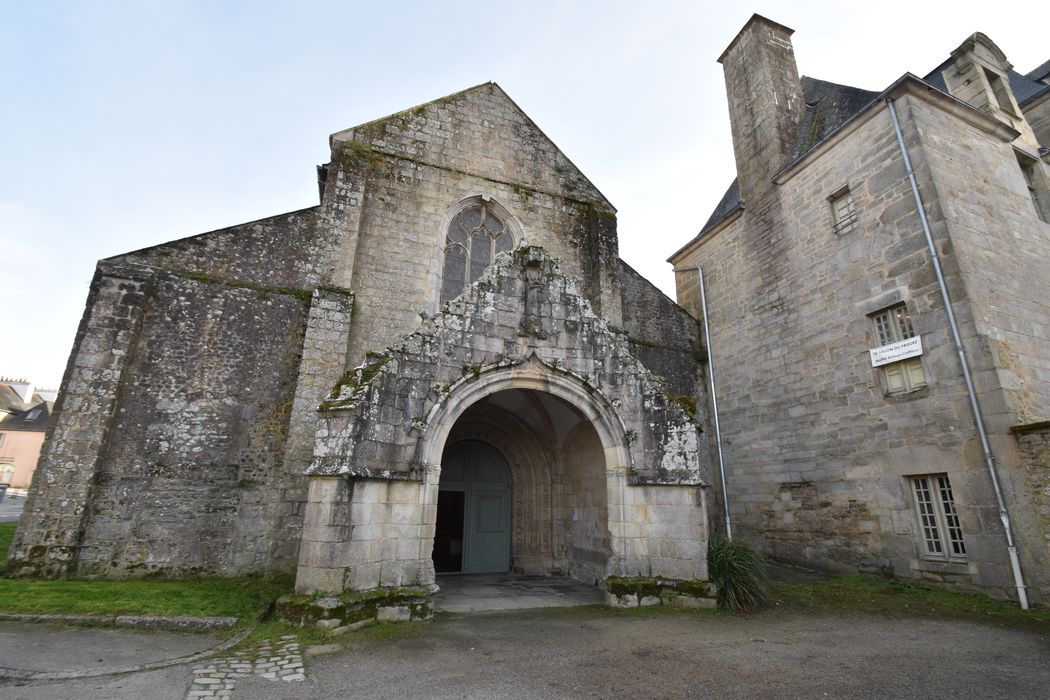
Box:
[0,576,292,621]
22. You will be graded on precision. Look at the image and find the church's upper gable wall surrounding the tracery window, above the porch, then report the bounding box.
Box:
[328,84,621,364]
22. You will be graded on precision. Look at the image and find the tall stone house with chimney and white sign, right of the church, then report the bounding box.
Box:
[670,16,1050,603]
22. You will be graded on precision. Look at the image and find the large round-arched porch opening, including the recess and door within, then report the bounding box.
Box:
[433,386,613,586]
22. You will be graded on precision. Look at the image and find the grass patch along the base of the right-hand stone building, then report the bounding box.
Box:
[772,576,1050,629]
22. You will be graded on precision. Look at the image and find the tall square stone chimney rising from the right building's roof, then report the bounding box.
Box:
[718,15,804,205]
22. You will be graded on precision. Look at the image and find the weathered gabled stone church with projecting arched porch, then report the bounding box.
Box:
[11,84,709,608]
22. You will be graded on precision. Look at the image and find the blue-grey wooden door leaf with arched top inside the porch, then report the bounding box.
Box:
[436,440,511,574]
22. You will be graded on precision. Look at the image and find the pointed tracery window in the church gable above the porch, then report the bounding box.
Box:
[441,201,515,301]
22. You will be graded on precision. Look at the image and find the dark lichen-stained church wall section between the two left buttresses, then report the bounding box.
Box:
[78,273,307,575]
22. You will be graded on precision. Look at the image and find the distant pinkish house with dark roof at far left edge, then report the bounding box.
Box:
[0,379,55,489]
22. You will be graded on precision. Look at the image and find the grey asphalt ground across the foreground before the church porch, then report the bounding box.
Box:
[0,607,1050,700]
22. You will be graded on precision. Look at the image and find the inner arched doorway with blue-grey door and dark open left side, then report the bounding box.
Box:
[433,440,512,574]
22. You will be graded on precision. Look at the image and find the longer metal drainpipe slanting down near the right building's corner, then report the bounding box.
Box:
[886,98,1028,610]
